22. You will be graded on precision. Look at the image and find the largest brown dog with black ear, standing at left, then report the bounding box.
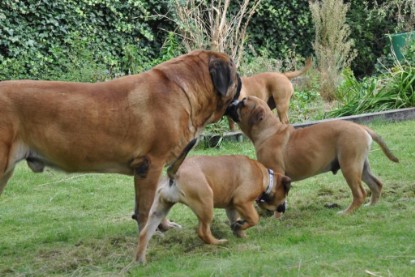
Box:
[0,51,241,231]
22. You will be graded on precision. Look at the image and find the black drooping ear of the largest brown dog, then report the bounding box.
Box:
[209,59,232,96]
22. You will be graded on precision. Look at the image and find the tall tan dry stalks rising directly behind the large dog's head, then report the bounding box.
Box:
[174,0,262,67]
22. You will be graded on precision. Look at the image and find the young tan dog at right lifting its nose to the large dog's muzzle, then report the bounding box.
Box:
[231,96,398,213]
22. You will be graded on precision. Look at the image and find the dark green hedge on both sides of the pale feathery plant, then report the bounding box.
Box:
[248,0,397,77]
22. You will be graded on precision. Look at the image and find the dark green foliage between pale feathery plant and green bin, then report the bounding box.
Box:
[347,0,415,78]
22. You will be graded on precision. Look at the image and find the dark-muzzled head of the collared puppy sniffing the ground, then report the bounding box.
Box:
[257,173,291,218]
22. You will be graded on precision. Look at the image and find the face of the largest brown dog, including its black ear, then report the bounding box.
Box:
[209,52,242,122]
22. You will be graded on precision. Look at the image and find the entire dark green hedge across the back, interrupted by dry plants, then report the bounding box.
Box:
[0,0,406,80]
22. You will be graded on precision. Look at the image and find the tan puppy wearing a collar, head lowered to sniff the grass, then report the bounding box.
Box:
[136,139,290,263]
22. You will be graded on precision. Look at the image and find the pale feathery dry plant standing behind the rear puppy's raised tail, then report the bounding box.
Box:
[309,0,357,102]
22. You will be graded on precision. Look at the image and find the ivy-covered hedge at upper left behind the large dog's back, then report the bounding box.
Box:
[0,0,171,80]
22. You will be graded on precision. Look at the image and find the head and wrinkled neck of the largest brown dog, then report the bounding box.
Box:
[152,50,242,125]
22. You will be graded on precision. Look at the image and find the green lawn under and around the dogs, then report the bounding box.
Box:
[0,121,415,276]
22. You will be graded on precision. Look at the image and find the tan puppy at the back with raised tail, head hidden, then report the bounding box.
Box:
[228,58,312,130]
